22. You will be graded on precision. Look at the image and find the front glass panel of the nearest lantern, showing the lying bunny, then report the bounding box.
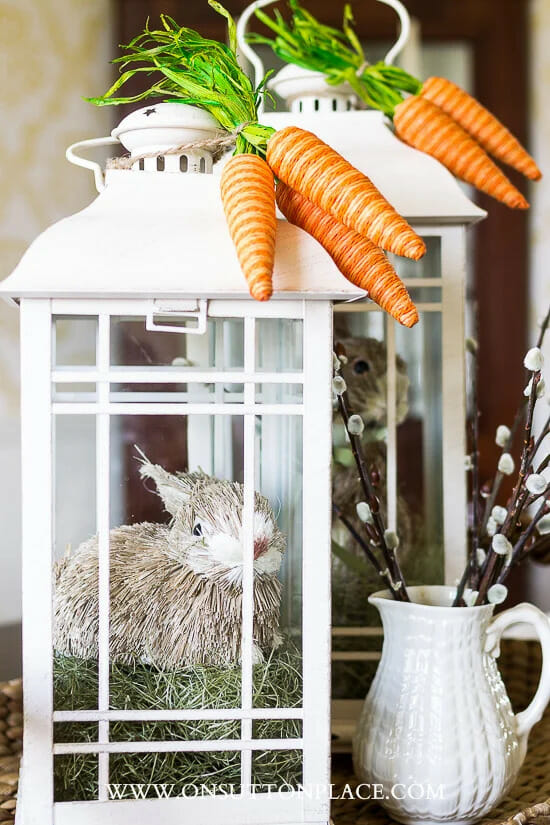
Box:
[52,306,310,801]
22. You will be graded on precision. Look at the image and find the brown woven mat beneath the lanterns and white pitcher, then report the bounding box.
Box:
[0,640,550,825]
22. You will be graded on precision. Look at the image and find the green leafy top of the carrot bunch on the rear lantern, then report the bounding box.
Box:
[247,0,422,117]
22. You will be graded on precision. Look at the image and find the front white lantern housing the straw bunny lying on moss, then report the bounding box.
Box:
[1,104,370,825]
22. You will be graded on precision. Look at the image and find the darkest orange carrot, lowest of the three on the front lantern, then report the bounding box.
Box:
[276,181,418,327]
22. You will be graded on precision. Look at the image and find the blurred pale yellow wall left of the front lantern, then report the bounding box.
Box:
[0,0,113,625]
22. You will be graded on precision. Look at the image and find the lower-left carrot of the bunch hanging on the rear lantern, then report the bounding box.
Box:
[393,95,529,209]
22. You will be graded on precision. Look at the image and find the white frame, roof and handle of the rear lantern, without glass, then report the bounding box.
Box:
[242,11,486,732]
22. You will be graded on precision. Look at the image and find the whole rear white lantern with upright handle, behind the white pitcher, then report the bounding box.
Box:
[239,20,486,740]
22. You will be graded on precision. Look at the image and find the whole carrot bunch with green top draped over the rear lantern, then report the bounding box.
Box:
[253,0,541,209]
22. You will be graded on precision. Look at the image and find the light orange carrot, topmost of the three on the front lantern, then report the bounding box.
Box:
[267,126,426,261]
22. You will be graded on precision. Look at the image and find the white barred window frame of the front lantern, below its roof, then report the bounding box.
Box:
[17,298,332,825]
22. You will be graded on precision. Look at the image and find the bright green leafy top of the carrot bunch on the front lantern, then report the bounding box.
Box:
[88,0,274,155]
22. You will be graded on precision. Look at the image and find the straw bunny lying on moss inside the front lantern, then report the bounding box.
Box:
[54,454,285,669]
